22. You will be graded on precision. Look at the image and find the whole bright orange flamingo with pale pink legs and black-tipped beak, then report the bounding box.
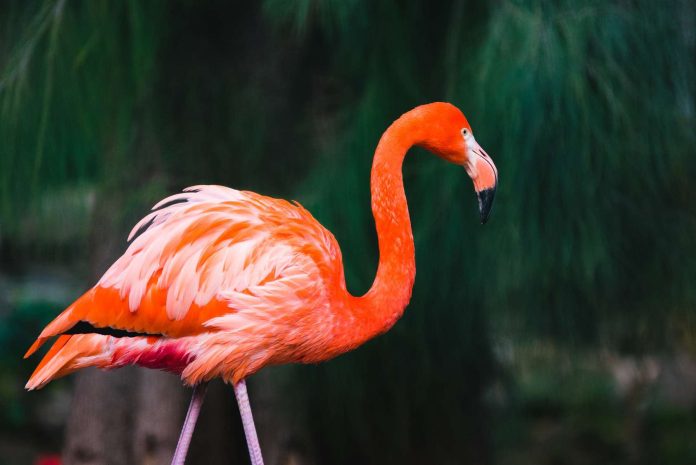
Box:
[25,102,498,465]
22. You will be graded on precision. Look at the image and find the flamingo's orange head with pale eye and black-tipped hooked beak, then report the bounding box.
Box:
[418,102,498,224]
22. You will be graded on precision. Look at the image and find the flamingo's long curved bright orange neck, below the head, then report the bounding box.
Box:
[360,113,421,333]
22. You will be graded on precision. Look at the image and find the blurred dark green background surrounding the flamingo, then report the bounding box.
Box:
[0,0,696,465]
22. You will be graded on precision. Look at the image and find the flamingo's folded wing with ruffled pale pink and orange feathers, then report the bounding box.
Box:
[27,186,343,384]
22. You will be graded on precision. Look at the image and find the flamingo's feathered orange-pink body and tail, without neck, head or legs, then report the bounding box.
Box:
[27,186,364,389]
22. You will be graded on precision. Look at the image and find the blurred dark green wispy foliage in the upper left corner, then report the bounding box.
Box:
[0,0,160,236]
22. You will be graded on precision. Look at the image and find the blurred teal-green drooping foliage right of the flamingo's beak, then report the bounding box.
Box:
[473,2,696,342]
